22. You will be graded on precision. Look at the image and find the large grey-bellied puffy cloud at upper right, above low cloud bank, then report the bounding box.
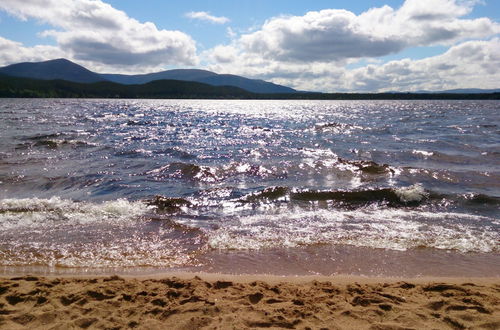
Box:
[238,0,500,62]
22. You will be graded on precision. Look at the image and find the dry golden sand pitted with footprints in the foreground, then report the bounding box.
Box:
[0,274,500,329]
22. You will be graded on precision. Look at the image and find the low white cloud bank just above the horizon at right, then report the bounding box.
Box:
[203,38,500,92]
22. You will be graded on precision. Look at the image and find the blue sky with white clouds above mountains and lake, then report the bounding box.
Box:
[0,0,500,92]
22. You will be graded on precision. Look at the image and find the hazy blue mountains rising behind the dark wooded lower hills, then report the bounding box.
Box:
[0,59,297,94]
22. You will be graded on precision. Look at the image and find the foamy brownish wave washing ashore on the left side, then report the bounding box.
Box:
[0,197,205,268]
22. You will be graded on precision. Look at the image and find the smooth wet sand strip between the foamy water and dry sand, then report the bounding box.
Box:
[0,246,500,279]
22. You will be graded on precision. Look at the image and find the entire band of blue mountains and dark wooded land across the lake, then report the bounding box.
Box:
[0,59,500,99]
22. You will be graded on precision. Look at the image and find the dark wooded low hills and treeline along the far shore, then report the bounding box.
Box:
[0,75,500,100]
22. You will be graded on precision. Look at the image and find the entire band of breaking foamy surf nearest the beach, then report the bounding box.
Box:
[0,191,500,267]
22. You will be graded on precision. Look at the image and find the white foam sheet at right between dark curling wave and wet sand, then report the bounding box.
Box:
[207,206,500,252]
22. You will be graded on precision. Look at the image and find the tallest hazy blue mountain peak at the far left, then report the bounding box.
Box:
[0,58,105,83]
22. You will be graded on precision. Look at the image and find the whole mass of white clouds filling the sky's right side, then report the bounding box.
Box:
[201,0,500,92]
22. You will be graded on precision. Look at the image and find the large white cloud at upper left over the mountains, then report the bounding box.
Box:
[0,0,197,71]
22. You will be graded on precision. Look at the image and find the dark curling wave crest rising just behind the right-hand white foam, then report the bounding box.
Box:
[145,184,500,216]
